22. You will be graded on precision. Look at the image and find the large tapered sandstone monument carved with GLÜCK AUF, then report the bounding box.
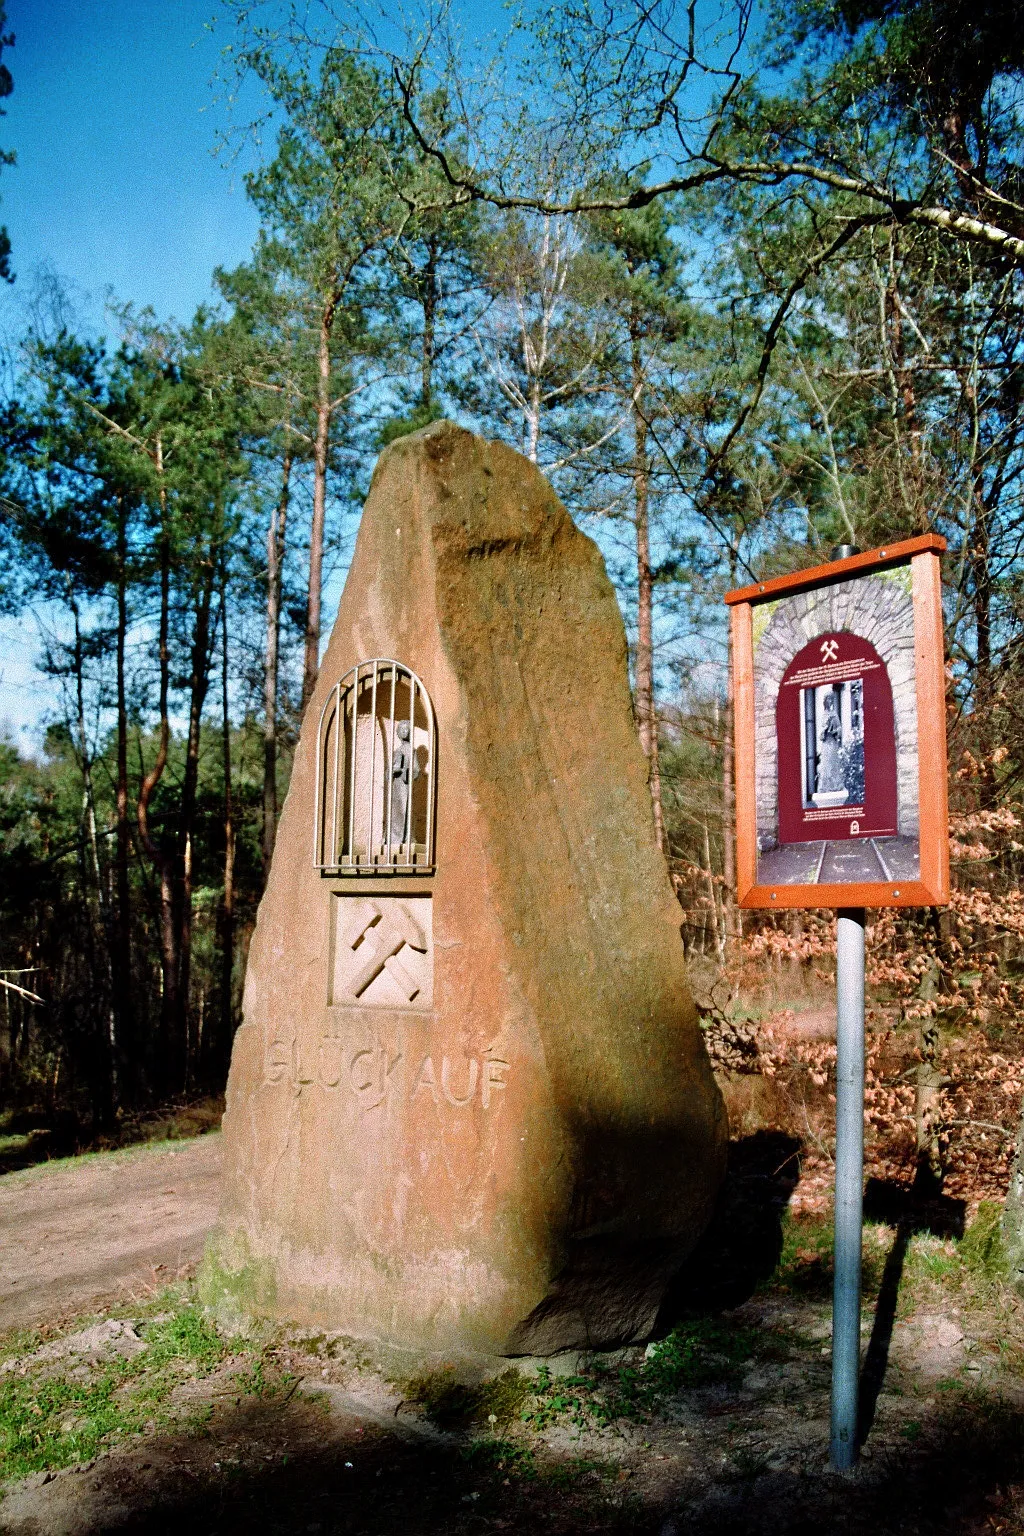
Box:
[203,422,726,1355]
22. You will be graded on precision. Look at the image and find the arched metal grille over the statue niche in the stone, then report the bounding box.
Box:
[313,657,436,874]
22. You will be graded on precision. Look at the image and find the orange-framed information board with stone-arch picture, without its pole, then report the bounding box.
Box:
[725,533,949,908]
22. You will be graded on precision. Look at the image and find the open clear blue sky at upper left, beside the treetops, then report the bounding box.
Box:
[0,0,268,750]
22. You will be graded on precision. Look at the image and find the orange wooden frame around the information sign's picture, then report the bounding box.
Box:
[725,533,949,908]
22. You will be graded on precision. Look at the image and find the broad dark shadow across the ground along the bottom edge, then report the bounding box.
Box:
[2,1376,1024,1536]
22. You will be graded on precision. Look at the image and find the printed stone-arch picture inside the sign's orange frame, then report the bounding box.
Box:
[752,565,920,886]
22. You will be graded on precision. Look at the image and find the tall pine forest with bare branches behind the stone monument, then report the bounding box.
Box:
[0,0,1024,1247]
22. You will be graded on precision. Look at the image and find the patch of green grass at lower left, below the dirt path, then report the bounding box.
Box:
[0,1304,226,1481]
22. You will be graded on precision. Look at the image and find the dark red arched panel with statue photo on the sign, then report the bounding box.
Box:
[775,631,897,843]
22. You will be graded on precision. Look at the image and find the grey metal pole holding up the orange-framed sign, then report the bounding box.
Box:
[831,906,864,1471]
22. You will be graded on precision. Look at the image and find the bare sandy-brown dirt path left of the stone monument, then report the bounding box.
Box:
[0,1134,221,1330]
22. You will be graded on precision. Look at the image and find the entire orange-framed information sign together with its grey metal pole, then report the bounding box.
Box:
[725,533,949,1471]
